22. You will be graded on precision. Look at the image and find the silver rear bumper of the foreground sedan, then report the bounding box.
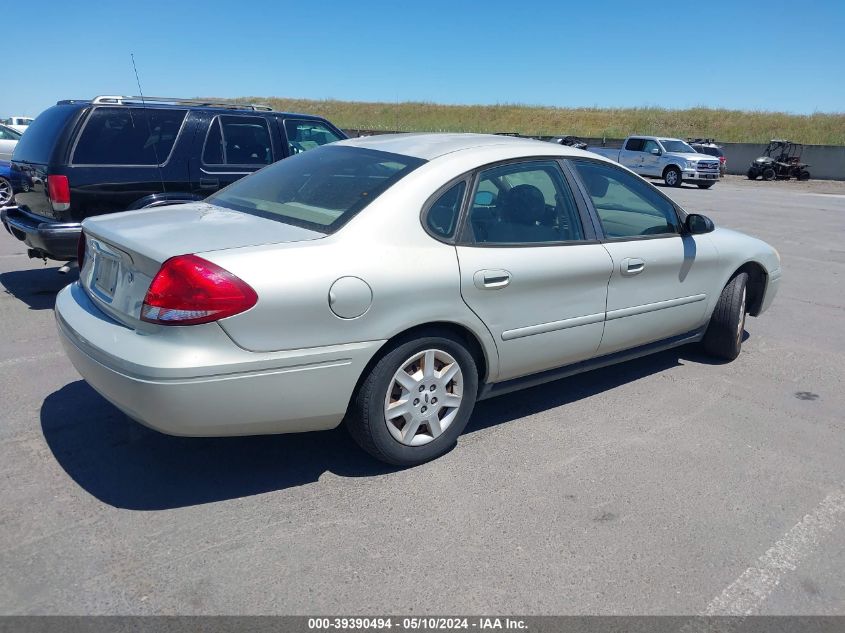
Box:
[56,283,383,436]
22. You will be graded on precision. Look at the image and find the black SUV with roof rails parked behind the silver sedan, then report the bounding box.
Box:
[0,96,346,261]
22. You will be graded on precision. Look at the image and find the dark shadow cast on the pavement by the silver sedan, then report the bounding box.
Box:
[41,346,714,510]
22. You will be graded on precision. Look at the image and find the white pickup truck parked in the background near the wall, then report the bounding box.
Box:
[587,136,719,189]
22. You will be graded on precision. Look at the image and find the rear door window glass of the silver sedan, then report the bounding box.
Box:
[469,161,584,244]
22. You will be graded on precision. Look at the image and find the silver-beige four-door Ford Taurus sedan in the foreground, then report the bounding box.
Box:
[51,134,781,465]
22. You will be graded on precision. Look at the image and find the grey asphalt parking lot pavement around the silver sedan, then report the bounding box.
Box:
[0,178,845,615]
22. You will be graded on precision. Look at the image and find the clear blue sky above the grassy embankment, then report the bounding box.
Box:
[0,0,845,116]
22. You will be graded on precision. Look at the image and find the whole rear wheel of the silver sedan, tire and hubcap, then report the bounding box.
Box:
[346,333,478,466]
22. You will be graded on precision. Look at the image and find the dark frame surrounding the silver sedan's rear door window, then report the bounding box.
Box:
[454,154,601,248]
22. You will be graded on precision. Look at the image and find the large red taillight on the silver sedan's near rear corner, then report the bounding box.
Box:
[141,255,258,325]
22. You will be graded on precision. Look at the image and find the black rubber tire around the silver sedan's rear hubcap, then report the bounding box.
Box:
[345,331,478,467]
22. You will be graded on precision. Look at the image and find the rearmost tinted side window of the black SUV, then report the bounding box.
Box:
[72,108,188,165]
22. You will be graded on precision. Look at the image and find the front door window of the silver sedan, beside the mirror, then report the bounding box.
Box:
[572,160,679,238]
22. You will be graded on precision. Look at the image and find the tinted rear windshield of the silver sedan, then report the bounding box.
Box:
[207,145,425,233]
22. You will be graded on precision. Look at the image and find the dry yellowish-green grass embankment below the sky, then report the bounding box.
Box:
[238,97,845,145]
